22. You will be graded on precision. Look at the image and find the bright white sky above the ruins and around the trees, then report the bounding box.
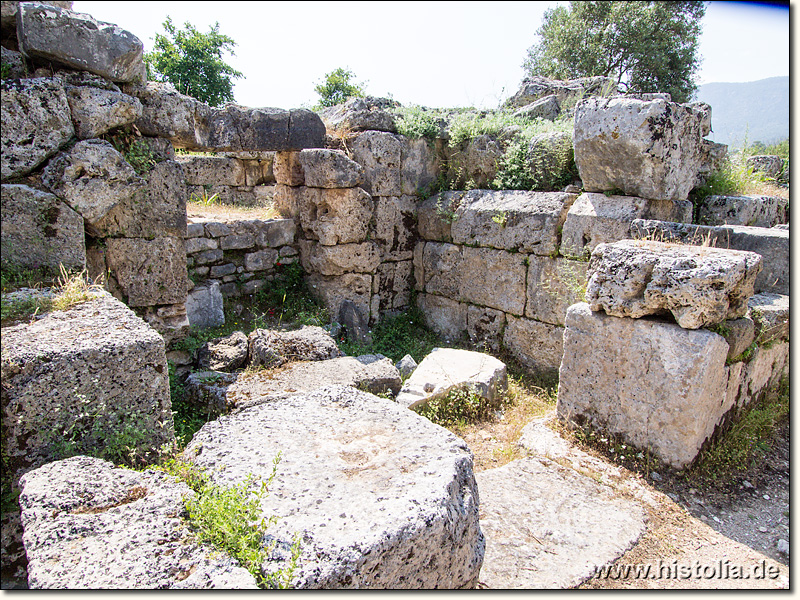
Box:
[73,0,789,108]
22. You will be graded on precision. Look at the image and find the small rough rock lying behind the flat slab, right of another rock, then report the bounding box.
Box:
[248,325,342,367]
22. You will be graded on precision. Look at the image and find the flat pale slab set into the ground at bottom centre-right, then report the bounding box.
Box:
[475,457,645,589]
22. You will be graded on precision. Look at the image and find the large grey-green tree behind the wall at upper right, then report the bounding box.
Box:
[523,1,706,102]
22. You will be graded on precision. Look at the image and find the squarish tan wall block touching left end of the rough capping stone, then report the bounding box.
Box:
[525,256,588,326]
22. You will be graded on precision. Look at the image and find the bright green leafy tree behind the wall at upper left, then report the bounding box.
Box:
[145,17,242,106]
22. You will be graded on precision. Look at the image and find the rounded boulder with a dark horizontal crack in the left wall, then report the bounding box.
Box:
[42,140,144,224]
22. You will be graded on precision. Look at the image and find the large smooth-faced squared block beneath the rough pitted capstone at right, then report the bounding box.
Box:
[557,303,733,468]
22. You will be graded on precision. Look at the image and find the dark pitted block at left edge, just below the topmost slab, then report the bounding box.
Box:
[0,78,75,181]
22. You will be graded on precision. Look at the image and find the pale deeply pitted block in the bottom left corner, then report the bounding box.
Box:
[20,456,257,590]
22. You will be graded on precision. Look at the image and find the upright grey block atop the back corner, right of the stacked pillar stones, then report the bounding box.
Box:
[351,131,403,196]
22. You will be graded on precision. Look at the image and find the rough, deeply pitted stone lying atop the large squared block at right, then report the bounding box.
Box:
[586,240,761,329]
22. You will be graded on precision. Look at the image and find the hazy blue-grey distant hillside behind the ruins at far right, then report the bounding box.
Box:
[697,77,789,147]
